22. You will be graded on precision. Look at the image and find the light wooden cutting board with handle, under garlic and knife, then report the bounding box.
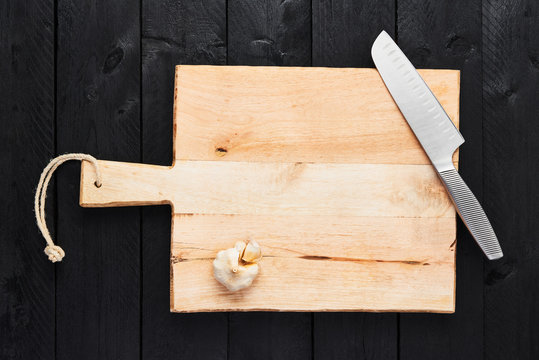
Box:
[80,65,459,312]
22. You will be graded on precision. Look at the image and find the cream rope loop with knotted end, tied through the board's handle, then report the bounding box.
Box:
[34,153,103,263]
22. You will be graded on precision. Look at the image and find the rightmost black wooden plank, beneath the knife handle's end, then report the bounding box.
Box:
[482,0,539,359]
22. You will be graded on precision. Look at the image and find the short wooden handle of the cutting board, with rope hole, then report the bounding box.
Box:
[79,160,171,207]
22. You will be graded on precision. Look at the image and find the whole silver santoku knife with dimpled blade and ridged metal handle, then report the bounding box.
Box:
[371,31,503,260]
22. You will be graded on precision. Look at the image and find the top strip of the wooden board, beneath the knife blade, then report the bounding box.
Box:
[174,66,459,164]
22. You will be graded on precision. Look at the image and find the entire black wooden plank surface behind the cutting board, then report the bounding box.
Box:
[0,0,539,359]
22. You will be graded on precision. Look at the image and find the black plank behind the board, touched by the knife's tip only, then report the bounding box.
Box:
[312,0,398,359]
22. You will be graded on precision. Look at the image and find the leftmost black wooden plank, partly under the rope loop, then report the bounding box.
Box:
[0,0,55,359]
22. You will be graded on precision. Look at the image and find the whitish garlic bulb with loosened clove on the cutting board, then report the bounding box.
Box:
[213,241,262,291]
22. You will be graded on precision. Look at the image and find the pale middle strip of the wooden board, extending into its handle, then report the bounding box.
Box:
[80,160,455,219]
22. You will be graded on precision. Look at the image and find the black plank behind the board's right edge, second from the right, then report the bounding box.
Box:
[397,0,483,360]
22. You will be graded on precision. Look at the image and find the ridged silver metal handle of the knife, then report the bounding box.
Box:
[440,169,503,260]
